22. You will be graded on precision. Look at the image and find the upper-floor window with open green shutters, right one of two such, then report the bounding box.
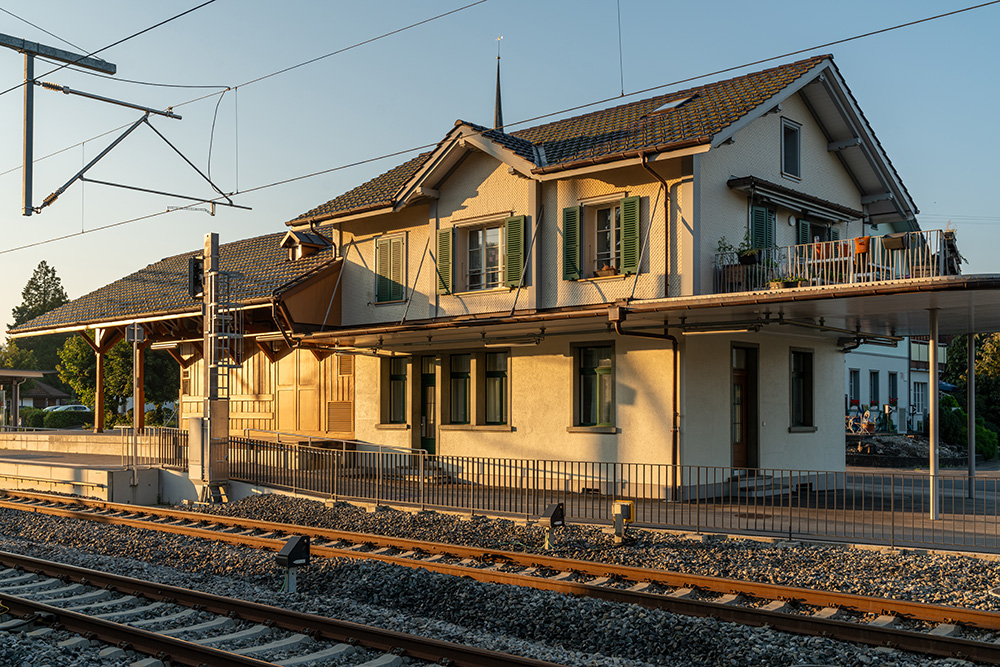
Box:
[563,197,641,280]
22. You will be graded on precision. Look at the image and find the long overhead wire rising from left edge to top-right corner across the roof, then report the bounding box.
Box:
[0,0,1000,255]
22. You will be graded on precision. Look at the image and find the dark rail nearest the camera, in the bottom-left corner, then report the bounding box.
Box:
[0,593,273,667]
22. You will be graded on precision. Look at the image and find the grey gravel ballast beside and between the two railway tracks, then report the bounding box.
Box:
[0,495,988,667]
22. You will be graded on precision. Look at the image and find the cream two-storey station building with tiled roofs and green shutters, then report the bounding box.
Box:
[12,56,1000,482]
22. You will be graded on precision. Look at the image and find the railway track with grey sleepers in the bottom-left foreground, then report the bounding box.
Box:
[0,552,555,667]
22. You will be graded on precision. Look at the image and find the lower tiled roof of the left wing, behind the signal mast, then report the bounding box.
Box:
[11,228,334,333]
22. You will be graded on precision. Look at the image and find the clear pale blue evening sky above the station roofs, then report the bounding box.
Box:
[0,0,1000,330]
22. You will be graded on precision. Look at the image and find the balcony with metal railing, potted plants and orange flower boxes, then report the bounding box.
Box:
[713,230,962,294]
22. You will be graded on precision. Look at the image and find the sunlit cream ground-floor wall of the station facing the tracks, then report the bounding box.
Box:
[355,335,673,463]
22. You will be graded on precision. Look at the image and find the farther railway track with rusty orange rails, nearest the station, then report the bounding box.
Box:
[0,492,1000,664]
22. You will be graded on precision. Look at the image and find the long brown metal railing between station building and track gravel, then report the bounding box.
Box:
[230,438,1000,550]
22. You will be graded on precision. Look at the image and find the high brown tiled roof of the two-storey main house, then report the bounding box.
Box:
[288,55,831,225]
